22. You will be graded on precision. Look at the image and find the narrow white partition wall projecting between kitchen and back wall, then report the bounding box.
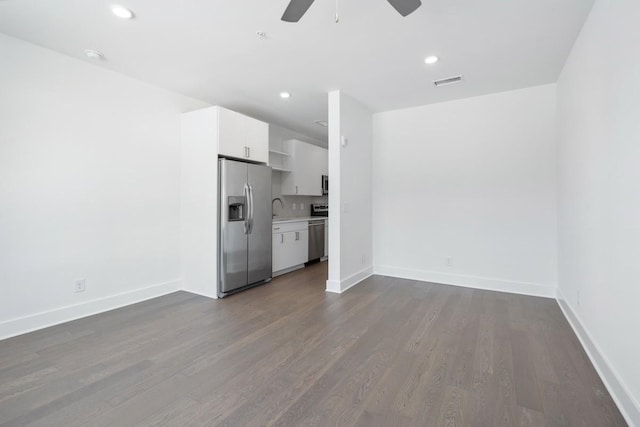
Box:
[327,91,373,292]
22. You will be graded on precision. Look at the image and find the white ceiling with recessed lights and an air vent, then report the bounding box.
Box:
[0,0,594,138]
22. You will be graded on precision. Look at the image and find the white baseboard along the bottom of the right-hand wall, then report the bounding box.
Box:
[557,289,640,427]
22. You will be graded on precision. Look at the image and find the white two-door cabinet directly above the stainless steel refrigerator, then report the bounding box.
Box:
[218,107,269,163]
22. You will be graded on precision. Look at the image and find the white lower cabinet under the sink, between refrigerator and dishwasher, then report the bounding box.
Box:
[272,221,309,276]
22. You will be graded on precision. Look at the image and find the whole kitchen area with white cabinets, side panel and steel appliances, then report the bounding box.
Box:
[181,106,329,298]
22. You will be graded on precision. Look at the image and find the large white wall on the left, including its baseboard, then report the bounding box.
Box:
[0,35,203,338]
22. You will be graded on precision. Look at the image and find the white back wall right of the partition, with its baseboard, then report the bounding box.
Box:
[373,85,557,296]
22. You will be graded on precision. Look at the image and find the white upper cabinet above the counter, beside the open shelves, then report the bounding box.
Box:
[282,139,329,196]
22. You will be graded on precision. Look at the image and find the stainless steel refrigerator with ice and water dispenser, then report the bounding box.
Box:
[218,159,272,298]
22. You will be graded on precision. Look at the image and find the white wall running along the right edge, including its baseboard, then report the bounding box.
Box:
[558,0,640,426]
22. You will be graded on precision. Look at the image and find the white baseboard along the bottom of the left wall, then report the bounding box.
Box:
[0,280,181,339]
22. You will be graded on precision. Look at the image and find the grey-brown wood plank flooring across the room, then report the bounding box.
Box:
[0,263,626,427]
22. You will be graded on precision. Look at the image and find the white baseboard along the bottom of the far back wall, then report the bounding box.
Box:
[374,265,557,298]
